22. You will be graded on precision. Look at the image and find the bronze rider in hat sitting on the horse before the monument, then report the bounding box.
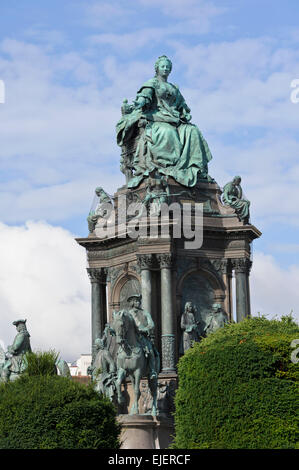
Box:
[127,294,159,378]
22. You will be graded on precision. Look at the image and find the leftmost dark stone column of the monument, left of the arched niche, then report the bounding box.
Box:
[87,268,107,359]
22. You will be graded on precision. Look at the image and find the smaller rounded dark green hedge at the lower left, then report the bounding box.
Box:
[0,374,120,449]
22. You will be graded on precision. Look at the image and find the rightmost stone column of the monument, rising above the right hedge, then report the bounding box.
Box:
[232,258,251,322]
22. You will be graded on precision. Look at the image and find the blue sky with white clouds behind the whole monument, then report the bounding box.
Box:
[0,0,299,360]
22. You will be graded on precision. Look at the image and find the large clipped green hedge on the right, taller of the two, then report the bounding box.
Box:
[173,317,299,449]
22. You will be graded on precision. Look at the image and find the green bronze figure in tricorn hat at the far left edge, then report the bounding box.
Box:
[0,320,31,382]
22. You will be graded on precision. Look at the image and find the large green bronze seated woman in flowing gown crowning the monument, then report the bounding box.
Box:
[116,56,212,188]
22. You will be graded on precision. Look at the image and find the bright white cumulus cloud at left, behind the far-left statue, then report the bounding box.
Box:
[0,222,91,361]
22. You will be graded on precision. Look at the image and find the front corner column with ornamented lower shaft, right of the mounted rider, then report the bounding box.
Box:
[157,253,175,372]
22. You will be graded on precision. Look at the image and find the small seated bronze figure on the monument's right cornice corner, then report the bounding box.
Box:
[222,176,250,223]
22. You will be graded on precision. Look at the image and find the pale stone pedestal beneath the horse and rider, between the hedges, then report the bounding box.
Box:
[118,415,174,449]
